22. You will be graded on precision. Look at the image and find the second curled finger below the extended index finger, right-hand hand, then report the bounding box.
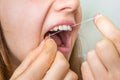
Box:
[87,50,107,80]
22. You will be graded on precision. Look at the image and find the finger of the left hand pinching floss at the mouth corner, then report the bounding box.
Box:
[10,39,57,80]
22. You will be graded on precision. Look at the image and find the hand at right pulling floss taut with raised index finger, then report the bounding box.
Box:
[81,15,120,80]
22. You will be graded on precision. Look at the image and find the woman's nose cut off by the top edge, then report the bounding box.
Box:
[55,0,80,12]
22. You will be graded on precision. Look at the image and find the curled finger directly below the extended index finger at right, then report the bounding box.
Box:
[96,39,120,71]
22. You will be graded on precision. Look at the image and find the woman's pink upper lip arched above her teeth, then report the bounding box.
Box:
[45,20,75,34]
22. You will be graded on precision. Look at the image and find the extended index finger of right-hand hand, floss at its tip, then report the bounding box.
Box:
[95,15,120,53]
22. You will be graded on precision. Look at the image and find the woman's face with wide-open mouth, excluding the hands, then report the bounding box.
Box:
[0,0,81,61]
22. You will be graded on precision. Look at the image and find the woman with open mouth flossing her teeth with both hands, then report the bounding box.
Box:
[0,0,120,80]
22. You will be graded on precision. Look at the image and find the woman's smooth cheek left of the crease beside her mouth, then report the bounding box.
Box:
[1,0,52,61]
